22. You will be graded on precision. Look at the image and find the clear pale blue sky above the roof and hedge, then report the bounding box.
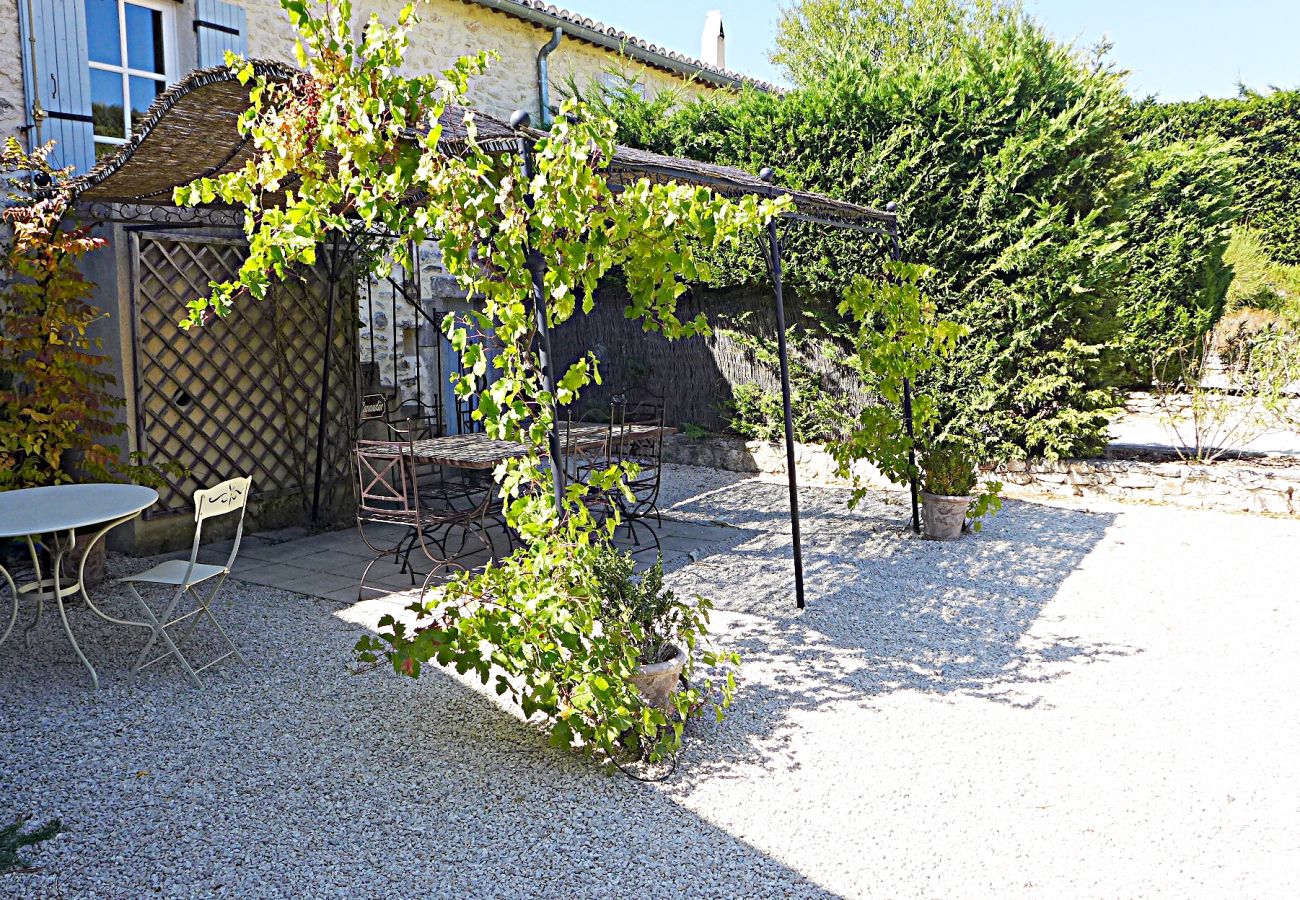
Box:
[572,0,1300,100]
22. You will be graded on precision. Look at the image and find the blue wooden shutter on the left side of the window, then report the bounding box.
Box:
[18,0,95,173]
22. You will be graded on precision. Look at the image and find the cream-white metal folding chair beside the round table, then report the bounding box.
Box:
[120,479,252,688]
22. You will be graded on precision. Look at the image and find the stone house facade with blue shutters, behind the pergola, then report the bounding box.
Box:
[0,0,772,550]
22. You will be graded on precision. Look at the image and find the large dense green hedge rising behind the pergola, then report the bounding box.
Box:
[592,18,1268,458]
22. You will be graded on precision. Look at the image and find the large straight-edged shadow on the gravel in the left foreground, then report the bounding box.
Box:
[0,577,835,899]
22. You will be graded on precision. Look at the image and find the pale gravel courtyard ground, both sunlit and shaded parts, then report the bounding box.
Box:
[0,467,1300,899]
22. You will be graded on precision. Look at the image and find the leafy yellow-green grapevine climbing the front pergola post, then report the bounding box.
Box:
[177,0,783,758]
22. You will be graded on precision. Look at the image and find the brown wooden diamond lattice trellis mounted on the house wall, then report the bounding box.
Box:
[133,233,358,512]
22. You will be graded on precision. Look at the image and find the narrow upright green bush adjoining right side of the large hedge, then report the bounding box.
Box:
[1118,134,1238,382]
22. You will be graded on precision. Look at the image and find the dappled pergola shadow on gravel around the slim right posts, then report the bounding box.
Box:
[688,496,1140,775]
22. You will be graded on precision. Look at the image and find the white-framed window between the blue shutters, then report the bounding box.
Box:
[85,0,177,157]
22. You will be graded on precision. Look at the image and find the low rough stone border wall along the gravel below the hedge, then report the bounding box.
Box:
[663,434,1300,518]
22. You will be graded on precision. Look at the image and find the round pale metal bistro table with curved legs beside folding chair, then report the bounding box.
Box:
[0,484,159,688]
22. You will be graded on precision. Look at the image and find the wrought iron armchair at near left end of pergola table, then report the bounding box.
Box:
[355,441,480,600]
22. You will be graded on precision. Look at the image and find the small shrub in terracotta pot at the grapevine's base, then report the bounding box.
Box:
[594,545,710,713]
